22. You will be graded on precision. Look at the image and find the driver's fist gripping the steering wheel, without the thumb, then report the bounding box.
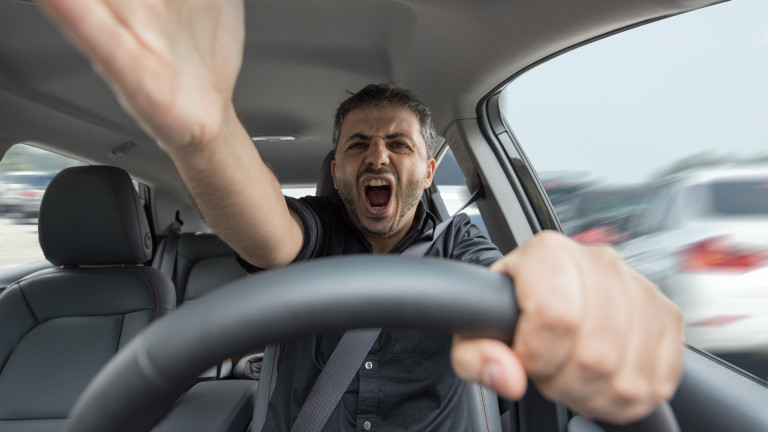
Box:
[492,232,684,423]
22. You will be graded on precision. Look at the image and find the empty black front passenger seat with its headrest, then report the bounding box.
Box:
[0,166,176,432]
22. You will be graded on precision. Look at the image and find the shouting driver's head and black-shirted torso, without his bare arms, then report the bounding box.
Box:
[243,84,501,432]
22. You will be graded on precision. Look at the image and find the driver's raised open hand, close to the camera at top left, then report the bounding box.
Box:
[41,0,245,149]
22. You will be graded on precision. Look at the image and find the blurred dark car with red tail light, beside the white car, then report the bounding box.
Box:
[558,186,646,244]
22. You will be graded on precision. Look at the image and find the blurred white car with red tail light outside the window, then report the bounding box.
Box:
[620,166,768,363]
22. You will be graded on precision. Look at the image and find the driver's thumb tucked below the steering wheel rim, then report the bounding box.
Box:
[451,336,527,400]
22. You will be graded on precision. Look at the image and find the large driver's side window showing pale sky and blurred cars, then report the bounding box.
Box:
[500,0,768,379]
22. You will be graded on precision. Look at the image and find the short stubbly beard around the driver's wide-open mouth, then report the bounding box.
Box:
[336,168,426,238]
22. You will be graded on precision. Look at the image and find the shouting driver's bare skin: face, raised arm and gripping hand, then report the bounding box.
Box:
[41,0,683,423]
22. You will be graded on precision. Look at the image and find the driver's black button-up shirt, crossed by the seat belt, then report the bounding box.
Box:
[246,197,501,432]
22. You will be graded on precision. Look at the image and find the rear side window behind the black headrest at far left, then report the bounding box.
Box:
[0,144,83,269]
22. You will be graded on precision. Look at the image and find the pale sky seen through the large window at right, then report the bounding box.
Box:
[501,0,768,184]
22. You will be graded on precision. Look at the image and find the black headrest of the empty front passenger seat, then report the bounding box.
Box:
[38,166,152,265]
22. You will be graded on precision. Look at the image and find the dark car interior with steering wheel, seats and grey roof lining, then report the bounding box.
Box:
[0,0,768,432]
